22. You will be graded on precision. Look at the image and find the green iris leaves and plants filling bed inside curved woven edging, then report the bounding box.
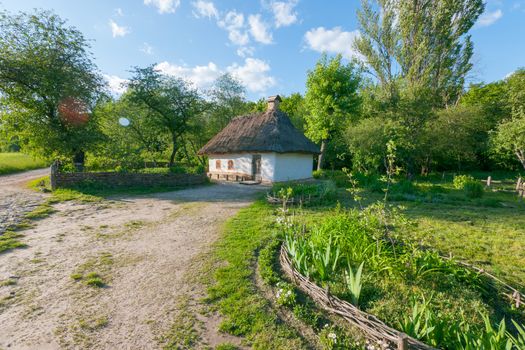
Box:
[285,204,520,346]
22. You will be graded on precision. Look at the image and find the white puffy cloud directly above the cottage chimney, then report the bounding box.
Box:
[227,58,276,93]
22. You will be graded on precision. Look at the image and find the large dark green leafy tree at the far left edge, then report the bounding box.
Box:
[0,11,103,163]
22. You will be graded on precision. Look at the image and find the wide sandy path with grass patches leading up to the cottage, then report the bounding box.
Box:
[0,185,260,349]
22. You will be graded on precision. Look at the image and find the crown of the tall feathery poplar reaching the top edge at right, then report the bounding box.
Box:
[355,0,484,107]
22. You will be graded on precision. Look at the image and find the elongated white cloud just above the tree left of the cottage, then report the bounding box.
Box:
[155,61,223,89]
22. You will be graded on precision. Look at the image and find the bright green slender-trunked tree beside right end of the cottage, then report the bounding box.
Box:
[305,55,361,170]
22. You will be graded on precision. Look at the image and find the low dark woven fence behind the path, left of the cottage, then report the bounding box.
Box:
[51,165,207,189]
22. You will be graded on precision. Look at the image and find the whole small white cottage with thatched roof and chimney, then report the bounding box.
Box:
[199,96,319,183]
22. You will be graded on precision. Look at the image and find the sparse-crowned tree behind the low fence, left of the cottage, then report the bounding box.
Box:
[128,65,202,167]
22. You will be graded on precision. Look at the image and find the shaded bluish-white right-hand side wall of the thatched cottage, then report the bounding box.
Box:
[272,153,314,182]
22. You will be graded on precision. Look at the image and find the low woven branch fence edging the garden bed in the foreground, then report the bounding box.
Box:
[279,245,436,350]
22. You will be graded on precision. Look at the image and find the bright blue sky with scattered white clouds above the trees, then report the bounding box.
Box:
[0,0,525,99]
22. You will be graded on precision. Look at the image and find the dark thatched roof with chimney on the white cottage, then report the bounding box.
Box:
[199,96,319,154]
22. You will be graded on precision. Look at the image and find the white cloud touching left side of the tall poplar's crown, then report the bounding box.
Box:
[304,27,359,59]
